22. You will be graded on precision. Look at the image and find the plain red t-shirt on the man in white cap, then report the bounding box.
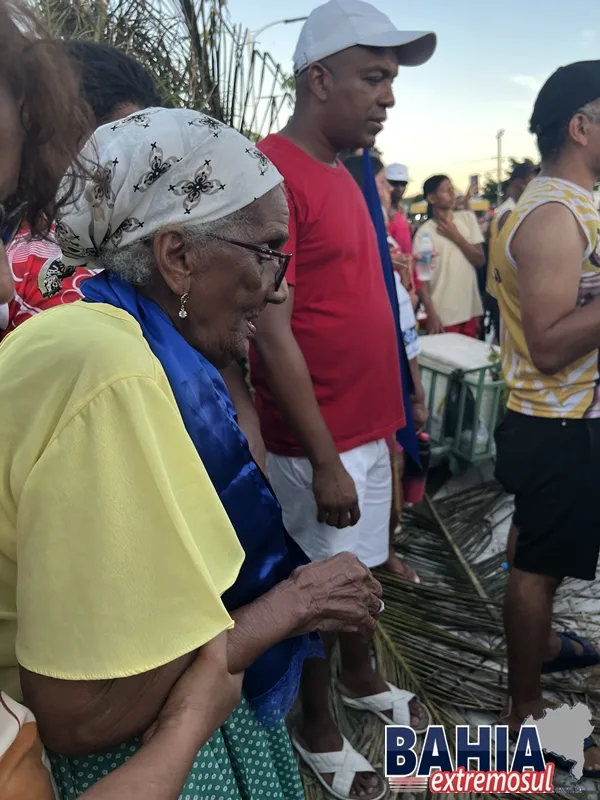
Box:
[251,134,405,456]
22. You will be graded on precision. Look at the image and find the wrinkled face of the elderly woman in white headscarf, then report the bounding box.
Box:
[149,186,289,369]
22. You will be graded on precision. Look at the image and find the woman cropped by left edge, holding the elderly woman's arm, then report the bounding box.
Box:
[0,7,251,800]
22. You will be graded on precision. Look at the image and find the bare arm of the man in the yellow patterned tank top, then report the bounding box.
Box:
[511,203,600,375]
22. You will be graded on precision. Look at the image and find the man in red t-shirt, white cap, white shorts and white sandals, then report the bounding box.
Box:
[251,0,436,798]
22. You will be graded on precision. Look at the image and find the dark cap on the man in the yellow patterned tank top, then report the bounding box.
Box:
[529,61,600,136]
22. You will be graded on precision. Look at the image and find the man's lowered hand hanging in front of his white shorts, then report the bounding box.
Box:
[313,458,360,528]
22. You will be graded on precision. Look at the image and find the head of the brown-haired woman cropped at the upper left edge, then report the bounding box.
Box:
[0,0,87,303]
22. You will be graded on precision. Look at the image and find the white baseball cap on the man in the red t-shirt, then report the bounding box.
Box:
[294,0,437,74]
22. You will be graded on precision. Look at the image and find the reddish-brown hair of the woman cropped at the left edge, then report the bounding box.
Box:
[0,0,90,236]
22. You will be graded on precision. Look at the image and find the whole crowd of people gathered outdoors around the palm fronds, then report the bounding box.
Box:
[0,0,600,800]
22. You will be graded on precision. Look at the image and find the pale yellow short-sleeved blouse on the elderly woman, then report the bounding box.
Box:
[0,302,243,699]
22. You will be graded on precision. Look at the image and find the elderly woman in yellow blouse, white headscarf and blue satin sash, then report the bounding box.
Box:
[0,109,381,800]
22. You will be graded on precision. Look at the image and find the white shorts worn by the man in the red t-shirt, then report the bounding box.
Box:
[267,439,392,567]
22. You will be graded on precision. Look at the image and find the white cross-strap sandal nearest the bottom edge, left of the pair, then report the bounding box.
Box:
[292,736,387,800]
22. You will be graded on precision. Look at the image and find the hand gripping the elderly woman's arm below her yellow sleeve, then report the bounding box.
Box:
[144,631,244,741]
